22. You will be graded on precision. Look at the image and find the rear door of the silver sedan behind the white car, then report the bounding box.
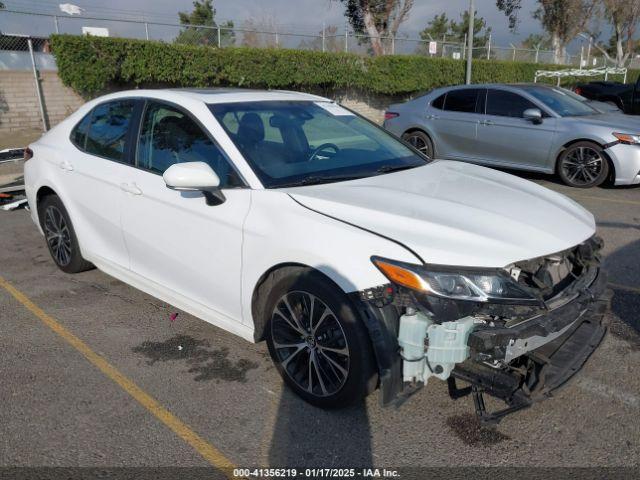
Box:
[429,88,485,161]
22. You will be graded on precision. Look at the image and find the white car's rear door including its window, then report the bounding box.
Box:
[65,99,140,269]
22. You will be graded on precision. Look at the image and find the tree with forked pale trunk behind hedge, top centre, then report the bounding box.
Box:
[339,0,413,55]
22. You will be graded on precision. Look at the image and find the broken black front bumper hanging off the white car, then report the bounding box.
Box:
[449,270,611,422]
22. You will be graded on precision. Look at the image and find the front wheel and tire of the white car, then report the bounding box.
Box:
[265,269,378,408]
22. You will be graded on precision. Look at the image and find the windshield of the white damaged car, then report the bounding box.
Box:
[209,101,428,188]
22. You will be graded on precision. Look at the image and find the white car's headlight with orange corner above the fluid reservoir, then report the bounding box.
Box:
[371,257,538,303]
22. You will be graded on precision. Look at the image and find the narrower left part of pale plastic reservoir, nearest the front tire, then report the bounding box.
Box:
[398,309,433,383]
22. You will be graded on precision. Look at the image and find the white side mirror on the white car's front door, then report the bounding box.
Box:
[162,162,226,205]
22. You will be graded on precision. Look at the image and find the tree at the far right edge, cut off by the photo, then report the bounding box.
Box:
[603,0,640,67]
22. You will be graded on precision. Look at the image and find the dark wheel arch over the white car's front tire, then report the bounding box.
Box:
[251,262,348,342]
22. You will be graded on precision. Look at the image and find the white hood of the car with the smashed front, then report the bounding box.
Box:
[285,160,595,267]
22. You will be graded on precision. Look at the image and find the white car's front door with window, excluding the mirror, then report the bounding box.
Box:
[122,101,251,321]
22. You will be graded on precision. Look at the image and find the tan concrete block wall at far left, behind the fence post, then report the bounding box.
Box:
[0,70,85,134]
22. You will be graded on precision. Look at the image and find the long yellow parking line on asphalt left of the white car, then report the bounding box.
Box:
[0,277,237,478]
